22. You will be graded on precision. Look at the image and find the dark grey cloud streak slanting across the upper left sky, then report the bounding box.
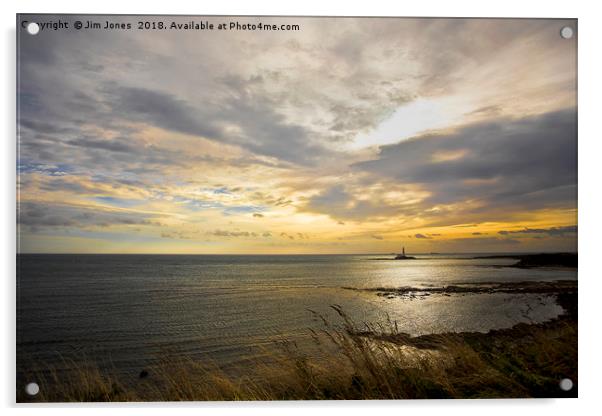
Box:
[104,83,333,164]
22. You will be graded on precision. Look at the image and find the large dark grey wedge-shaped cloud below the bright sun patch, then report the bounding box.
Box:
[355,109,577,212]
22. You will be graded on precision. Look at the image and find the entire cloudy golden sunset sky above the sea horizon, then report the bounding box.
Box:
[17,15,577,254]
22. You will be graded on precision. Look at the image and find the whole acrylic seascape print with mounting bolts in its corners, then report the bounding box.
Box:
[16,14,578,402]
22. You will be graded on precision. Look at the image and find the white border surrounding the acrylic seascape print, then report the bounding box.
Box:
[0,0,602,416]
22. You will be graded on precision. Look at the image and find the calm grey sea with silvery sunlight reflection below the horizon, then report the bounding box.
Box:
[17,254,577,372]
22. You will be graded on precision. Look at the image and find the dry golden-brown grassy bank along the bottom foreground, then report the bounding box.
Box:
[17,291,577,402]
